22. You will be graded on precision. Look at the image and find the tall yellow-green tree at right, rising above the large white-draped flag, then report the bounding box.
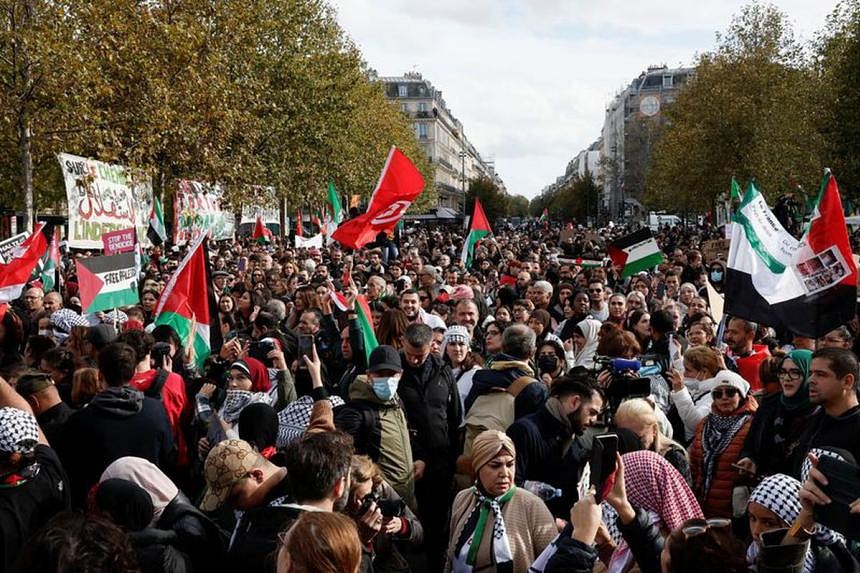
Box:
[646,3,823,212]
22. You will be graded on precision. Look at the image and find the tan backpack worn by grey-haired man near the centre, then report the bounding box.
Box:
[457,376,537,475]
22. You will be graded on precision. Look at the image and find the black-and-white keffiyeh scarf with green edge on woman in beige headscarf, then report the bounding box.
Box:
[451,486,517,573]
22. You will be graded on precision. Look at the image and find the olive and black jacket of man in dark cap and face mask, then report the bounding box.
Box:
[335,374,416,507]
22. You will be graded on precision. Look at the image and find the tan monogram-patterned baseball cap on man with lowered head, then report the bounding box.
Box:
[200,440,261,511]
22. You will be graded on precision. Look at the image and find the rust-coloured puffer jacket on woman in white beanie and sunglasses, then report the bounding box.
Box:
[690,396,758,518]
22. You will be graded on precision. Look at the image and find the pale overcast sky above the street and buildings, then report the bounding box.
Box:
[330,0,836,198]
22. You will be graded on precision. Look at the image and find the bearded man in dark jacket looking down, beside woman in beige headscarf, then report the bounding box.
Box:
[507,368,603,519]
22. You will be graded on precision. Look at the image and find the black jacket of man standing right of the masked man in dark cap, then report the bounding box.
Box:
[397,353,462,475]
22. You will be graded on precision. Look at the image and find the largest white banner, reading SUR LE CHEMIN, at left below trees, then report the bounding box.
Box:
[57,153,152,250]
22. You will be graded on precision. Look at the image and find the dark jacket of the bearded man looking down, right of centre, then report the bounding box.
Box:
[507,402,587,519]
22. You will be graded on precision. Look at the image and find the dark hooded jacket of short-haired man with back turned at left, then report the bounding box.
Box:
[57,386,176,507]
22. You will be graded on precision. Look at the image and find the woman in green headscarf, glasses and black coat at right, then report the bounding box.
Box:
[738,350,818,476]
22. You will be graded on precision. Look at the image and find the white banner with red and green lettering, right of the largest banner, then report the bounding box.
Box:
[173,179,236,245]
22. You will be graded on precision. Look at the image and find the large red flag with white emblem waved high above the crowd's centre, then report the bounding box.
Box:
[332,146,424,249]
